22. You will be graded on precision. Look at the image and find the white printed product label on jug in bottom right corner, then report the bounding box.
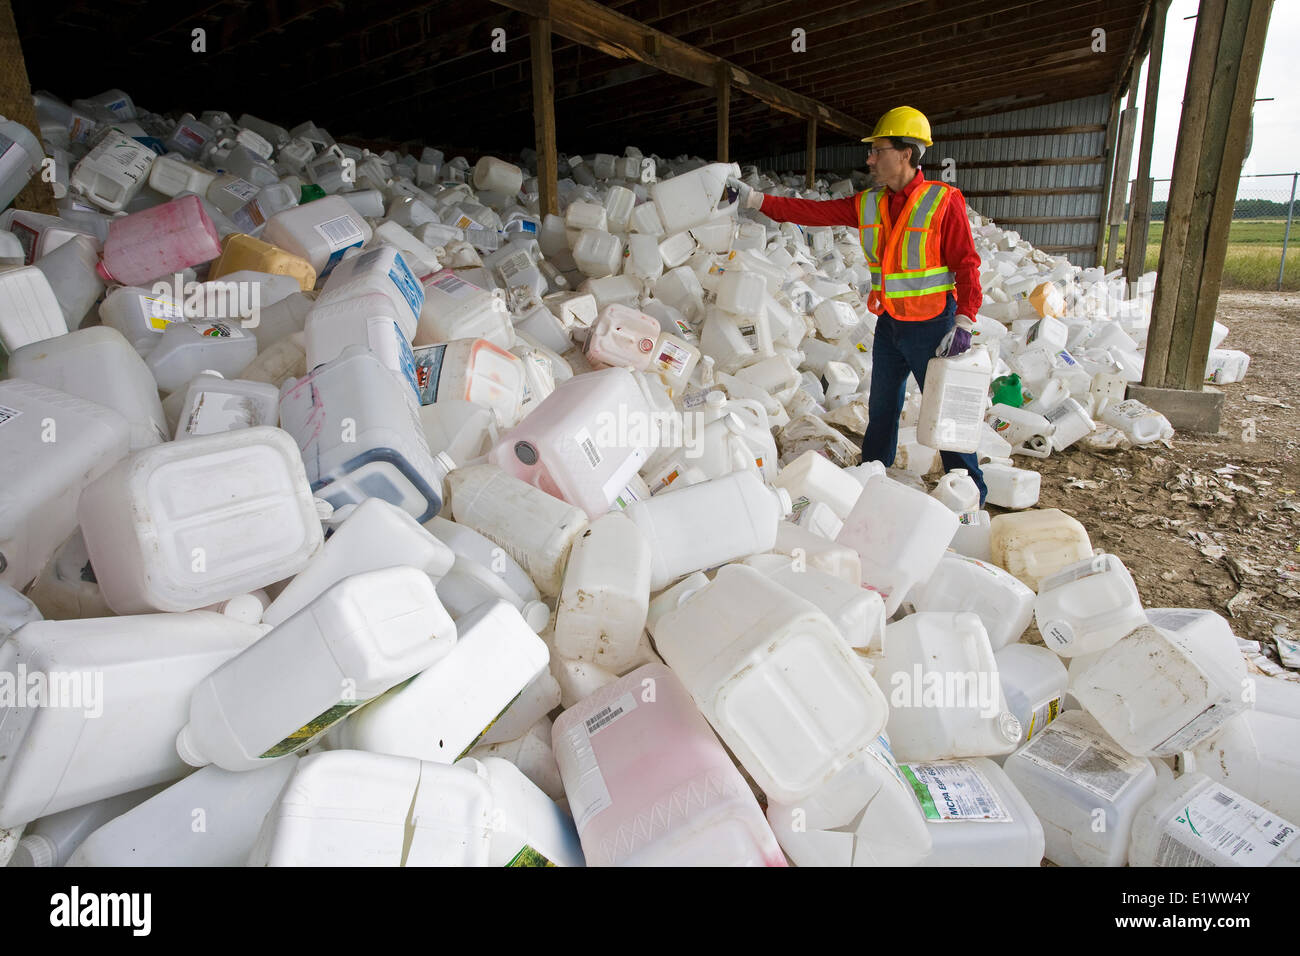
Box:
[1156,784,1296,866]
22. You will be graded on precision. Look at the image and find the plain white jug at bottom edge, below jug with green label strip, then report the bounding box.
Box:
[68,754,298,866]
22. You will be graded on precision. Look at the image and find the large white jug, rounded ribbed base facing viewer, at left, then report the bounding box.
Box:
[77,428,322,614]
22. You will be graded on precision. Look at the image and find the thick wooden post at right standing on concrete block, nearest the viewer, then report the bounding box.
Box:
[1143,0,1273,390]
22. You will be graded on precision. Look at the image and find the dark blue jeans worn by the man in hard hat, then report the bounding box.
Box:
[862,295,988,507]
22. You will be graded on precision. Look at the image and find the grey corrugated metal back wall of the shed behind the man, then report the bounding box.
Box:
[750,95,1110,265]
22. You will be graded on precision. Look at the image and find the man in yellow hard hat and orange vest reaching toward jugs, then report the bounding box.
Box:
[731,107,987,506]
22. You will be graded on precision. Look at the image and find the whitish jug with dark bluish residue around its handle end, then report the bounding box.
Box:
[280,345,454,522]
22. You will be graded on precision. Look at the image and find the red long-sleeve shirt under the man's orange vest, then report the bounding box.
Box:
[759,169,984,321]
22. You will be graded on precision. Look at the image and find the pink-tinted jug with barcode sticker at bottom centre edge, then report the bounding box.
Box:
[553,663,785,866]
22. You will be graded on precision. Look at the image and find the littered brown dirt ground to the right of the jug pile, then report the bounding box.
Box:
[1008,291,1300,663]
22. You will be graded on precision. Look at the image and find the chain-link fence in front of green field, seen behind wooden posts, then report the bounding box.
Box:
[1121,172,1300,291]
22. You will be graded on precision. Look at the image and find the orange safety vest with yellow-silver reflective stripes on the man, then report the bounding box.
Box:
[858,179,957,321]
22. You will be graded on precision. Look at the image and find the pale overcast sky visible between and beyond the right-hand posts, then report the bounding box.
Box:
[1130,0,1300,202]
